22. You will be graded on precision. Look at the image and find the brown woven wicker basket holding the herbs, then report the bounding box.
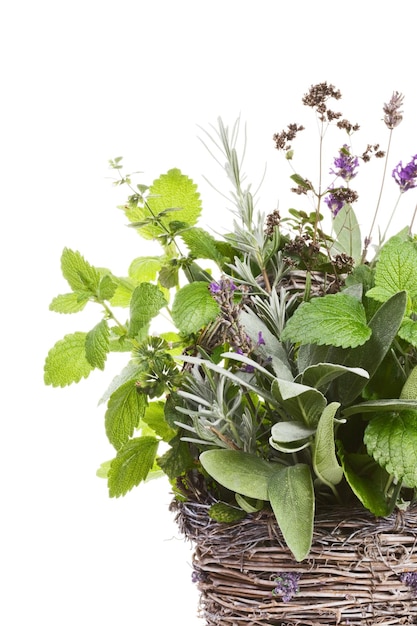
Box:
[177,502,417,626]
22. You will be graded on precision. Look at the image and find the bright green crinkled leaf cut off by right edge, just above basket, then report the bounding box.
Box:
[364,411,417,487]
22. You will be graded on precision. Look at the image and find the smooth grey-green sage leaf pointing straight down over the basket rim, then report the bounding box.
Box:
[268,463,314,561]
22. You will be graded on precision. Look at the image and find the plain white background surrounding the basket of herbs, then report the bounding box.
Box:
[0,0,417,626]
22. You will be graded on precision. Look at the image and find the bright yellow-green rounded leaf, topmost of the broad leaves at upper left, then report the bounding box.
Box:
[125,169,201,239]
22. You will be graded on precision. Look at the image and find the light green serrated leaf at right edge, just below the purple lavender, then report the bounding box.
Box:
[366,237,417,302]
